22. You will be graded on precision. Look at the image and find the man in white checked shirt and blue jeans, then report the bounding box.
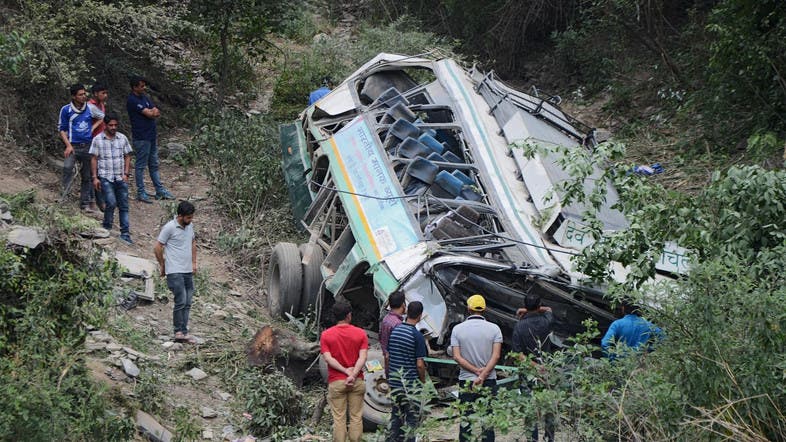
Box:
[90,113,133,244]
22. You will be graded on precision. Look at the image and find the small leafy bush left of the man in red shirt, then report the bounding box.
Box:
[237,367,305,436]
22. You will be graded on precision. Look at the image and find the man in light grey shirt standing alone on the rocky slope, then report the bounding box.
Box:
[153,201,197,343]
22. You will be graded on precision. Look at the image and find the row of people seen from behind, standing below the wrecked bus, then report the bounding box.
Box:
[321,292,662,442]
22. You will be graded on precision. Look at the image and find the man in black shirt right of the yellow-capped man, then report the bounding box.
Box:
[512,294,554,442]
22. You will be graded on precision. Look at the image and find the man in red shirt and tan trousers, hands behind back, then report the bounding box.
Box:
[320,301,368,442]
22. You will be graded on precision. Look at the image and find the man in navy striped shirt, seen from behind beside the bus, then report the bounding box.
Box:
[388,301,427,442]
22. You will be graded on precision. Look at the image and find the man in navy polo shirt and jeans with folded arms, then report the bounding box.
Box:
[126,76,175,204]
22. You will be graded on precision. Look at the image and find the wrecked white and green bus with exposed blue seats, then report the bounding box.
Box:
[266,53,680,426]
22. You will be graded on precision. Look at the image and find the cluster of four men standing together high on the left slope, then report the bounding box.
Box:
[58,76,174,244]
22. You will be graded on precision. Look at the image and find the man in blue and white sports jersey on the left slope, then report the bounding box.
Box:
[58,84,94,213]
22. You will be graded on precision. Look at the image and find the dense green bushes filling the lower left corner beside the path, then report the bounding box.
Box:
[0,198,133,441]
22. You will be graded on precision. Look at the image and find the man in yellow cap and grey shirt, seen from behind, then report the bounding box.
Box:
[450,294,502,442]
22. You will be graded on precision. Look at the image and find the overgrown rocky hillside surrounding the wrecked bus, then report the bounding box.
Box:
[0,0,786,442]
